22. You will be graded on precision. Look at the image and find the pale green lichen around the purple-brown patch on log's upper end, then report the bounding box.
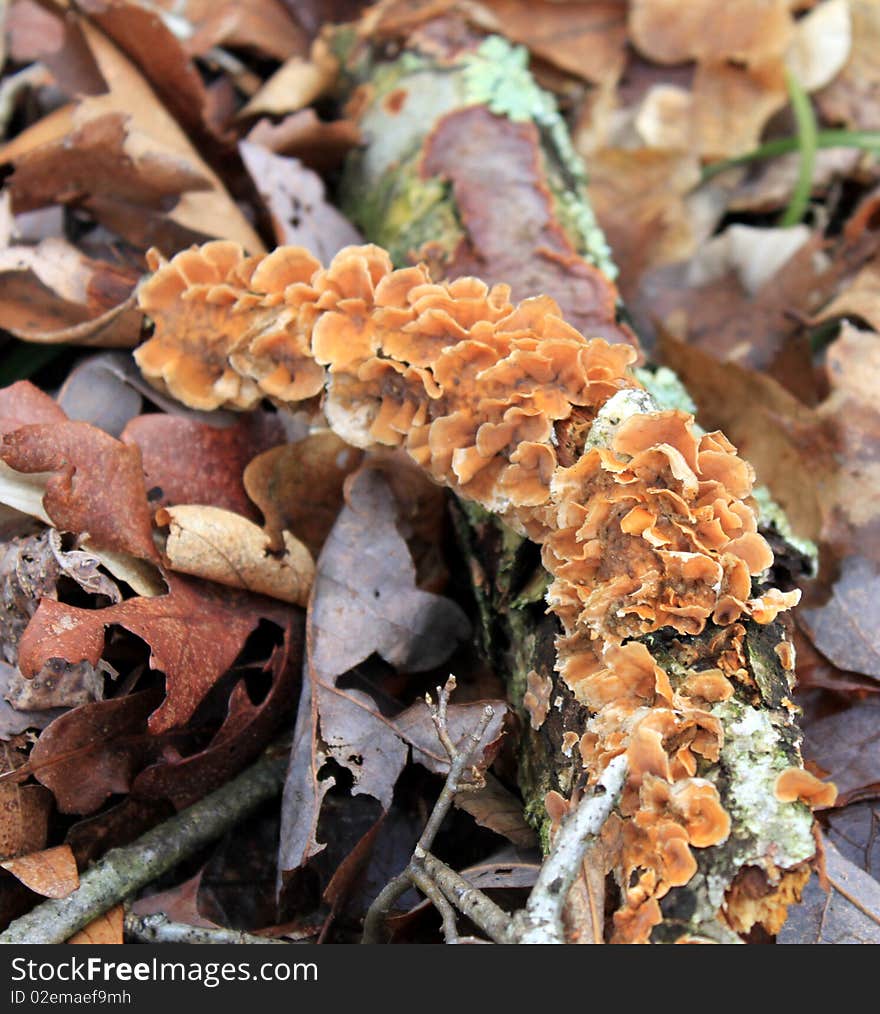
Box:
[335,35,617,279]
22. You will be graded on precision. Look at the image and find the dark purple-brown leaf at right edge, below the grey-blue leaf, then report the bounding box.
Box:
[804,699,880,809]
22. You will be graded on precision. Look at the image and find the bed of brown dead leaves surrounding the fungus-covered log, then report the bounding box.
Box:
[0,0,880,942]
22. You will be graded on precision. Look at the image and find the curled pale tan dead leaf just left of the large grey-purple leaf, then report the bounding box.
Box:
[156,504,314,605]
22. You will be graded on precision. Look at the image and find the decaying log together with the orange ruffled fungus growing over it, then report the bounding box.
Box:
[130,9,833,942]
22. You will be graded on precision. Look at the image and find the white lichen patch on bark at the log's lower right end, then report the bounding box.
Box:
[712,701,816,884]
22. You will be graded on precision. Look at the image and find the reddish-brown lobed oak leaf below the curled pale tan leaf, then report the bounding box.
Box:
[19,575,287,735]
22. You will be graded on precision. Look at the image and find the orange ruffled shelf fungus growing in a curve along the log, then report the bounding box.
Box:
[135,241,832,941]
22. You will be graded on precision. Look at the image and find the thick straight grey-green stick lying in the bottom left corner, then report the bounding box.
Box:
[0,754,287,944]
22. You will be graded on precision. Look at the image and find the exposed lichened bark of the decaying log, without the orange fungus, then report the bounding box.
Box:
[322,17,816,941]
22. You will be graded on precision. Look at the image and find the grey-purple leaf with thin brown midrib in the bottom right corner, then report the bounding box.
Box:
[777,839,880,944]
